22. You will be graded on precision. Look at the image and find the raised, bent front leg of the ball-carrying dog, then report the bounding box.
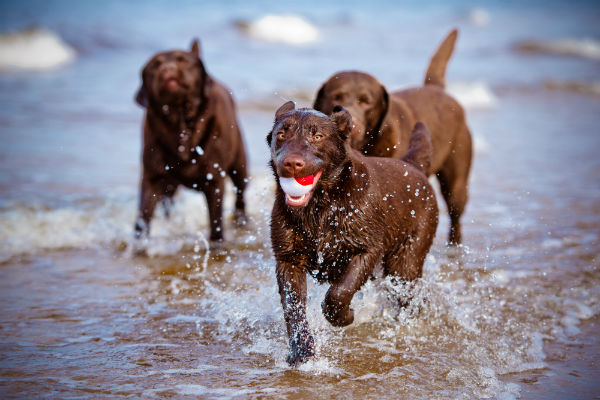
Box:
[321,253,381,326]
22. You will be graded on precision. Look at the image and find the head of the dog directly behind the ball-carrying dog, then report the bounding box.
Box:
[313,71,389,150]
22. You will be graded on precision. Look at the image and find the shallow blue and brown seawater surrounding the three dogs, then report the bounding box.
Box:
[0,2,600,399]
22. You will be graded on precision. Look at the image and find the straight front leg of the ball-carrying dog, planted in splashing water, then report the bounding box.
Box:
[276,263,315,365]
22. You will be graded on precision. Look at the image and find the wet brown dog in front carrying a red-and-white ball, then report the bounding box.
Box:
[267,102,438,365]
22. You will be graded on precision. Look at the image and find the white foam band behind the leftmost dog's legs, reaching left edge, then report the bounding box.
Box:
[0,174,275,260]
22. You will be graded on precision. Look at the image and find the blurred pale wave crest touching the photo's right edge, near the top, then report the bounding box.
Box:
[516,38,600,60]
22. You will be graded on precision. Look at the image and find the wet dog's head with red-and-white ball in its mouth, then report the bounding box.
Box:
[267,101,352,208]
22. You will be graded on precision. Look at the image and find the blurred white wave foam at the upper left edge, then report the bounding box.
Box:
[0,29,76,70]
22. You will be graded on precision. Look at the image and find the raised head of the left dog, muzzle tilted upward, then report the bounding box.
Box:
[136,40,208,107]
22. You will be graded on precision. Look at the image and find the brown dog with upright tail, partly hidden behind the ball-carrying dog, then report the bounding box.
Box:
[314,30,472,244]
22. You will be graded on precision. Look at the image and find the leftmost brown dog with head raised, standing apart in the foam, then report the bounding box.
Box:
[135,41,248,241]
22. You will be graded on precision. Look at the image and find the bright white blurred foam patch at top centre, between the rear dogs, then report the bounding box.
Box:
[240,15,319,45]
